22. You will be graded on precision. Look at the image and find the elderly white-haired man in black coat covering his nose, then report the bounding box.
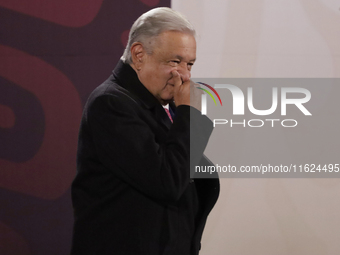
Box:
[71,8,219,255]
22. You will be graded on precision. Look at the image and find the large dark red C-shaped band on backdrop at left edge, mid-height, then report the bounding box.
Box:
[0,45,82,199]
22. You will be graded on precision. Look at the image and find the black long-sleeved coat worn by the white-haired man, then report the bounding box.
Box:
[71,61,219,255]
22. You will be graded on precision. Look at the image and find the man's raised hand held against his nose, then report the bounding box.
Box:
[172,71,203,111]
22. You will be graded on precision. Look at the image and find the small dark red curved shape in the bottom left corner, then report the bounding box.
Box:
[0,222,31,255]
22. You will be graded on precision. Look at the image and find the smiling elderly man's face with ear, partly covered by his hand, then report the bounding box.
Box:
[138,31,196,105]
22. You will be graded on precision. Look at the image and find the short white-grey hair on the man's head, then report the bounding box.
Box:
[121,7,196,64]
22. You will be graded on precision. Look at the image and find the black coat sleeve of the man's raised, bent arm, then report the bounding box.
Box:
[86,92,212,201]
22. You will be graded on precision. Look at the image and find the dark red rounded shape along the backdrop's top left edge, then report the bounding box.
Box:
[0,0,104,27]
